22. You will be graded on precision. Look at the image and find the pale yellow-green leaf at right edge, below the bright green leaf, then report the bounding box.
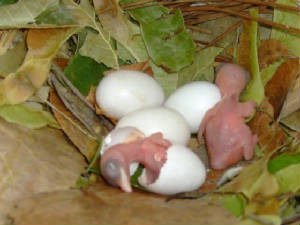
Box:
[275,163,300,193]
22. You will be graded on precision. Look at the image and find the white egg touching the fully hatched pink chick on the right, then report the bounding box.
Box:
[165,81,221,133]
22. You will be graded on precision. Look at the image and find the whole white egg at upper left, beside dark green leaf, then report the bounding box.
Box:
[96,70,165,119]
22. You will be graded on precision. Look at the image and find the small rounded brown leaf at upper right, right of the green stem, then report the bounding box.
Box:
[258,39,290,69]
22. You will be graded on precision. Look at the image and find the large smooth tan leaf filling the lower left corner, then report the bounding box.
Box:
[0,119,86,224]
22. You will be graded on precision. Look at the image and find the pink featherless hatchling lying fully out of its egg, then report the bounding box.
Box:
[198,64,257,169]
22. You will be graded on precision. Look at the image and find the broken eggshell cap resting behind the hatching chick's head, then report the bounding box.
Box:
[100,127,145,175]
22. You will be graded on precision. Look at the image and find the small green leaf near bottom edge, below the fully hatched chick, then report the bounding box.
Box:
[222,194,246,217]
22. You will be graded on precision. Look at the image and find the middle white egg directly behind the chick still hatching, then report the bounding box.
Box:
[116,107,191,145]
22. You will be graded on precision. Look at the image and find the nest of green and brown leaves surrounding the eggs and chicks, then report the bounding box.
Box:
[0,0,300,225]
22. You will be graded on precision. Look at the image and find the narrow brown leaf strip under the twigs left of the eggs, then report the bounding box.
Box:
[49,89,99,161]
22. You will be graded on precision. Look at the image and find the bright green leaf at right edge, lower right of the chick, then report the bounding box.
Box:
[268,153,300,174]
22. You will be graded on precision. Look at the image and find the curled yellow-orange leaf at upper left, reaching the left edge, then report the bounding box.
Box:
[0,28,76,105]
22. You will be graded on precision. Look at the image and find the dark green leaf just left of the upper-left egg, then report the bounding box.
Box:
[64,55,108,95]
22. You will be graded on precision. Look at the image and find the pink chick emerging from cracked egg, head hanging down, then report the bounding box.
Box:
[100,132,171,192]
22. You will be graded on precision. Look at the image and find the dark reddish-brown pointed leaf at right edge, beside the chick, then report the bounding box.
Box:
[265,58,299,120]
